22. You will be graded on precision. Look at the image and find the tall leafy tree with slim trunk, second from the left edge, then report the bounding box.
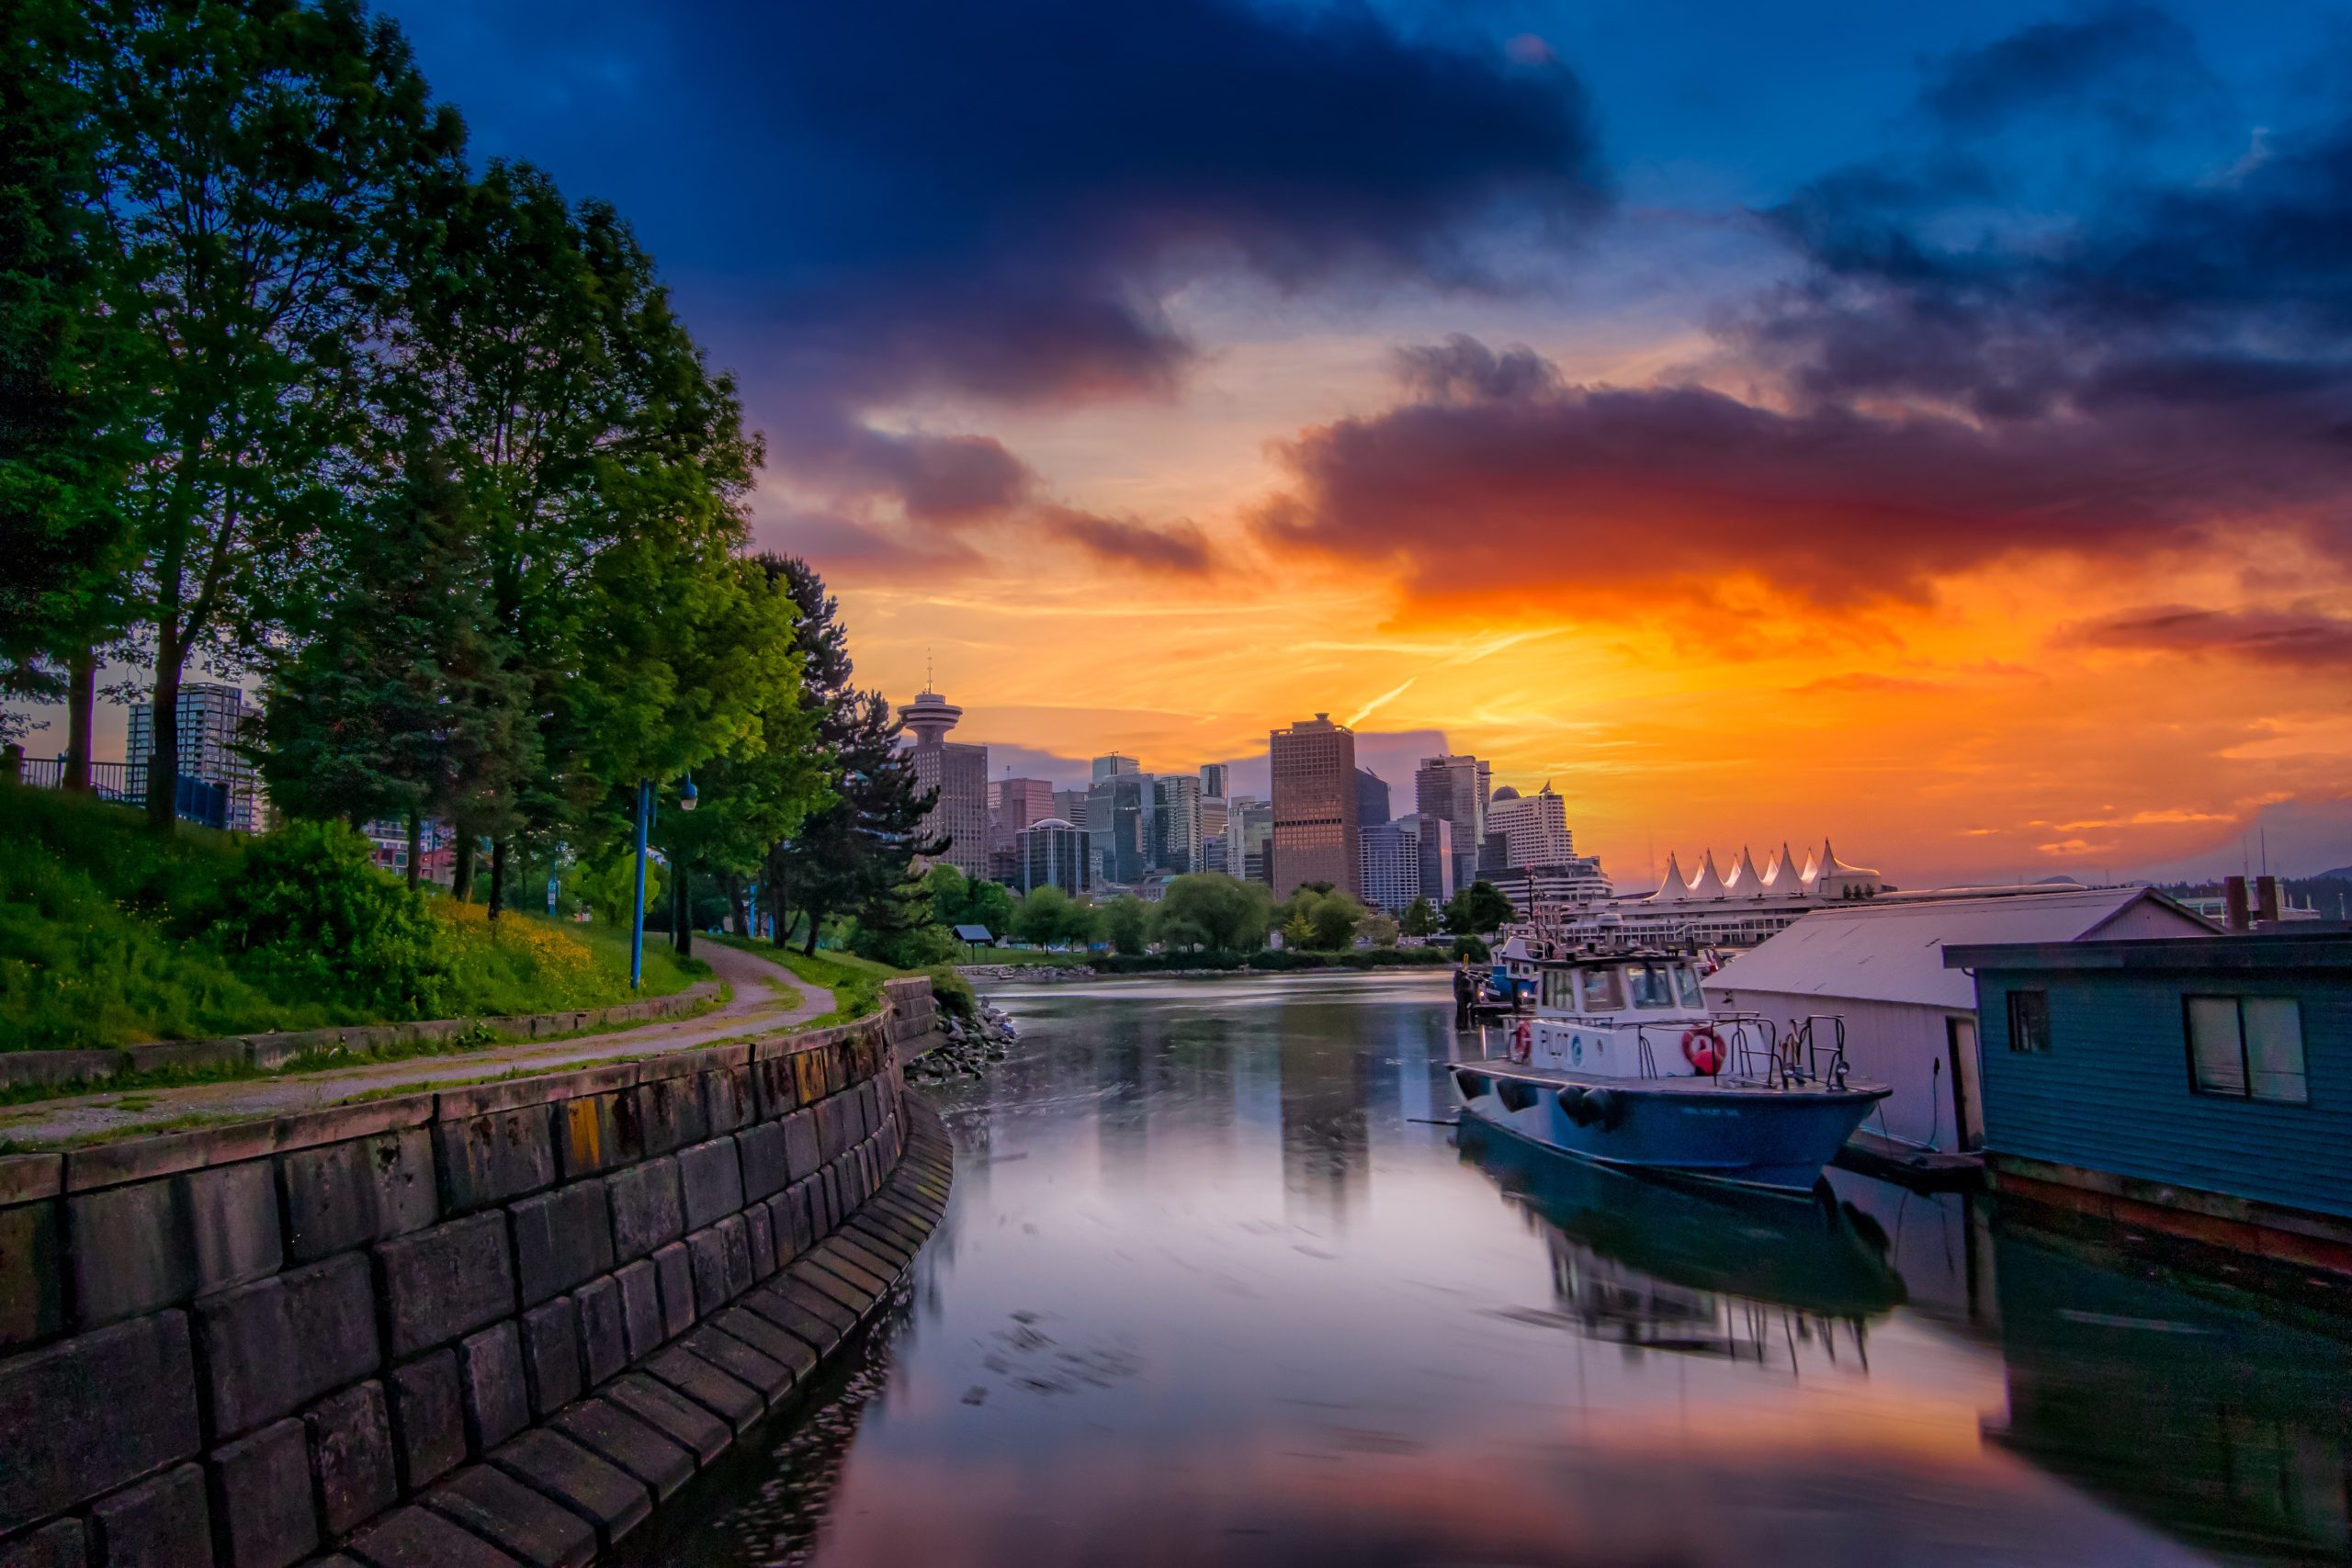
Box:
[75,0,463,828]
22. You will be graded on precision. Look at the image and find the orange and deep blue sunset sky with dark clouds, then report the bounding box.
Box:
[390,0,2352,886]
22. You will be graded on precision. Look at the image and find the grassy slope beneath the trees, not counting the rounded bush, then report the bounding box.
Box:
[0,785,710,1060]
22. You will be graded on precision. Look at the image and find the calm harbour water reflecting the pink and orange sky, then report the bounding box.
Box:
[633,978,2352,1568]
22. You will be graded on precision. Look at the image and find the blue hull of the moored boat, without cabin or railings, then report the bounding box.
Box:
[1453,1063,1889,1194]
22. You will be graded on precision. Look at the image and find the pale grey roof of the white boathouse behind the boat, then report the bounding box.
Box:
[1705,888,2213,1010]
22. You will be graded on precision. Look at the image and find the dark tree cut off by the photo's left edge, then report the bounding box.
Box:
[0,0,143,761]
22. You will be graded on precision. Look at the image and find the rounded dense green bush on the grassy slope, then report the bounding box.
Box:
[195,823,452,1018]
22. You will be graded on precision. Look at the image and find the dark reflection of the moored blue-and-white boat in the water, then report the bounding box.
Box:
[1458,1117,1903,1366]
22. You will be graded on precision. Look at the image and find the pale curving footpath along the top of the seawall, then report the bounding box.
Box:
[0,942,832,1149]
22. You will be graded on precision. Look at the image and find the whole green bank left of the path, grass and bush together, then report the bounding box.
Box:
[0,785,710,1051]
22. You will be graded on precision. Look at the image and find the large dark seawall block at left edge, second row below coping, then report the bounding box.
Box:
[0,1312,202,1535]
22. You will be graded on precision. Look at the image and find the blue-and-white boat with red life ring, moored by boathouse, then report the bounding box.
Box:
[1452,936,1891,1194]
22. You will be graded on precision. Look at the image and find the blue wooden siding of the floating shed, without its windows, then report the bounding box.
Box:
[1975,968,2352,1215]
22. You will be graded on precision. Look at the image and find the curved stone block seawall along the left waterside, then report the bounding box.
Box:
[0,980,948,1568]
